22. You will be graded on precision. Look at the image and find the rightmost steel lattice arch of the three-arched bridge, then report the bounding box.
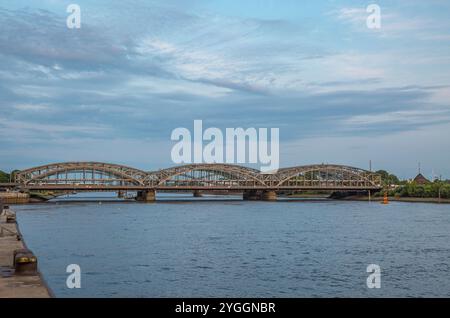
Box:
[276,164,381,189]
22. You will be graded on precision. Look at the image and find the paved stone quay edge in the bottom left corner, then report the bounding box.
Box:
[0,206,51,298]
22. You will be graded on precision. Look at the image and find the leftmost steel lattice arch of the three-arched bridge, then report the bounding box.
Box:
[15,162,147,186]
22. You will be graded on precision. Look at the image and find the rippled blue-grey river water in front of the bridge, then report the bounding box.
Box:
[15,196,450,297]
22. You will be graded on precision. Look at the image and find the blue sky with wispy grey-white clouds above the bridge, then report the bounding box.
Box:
[0,0,450,178]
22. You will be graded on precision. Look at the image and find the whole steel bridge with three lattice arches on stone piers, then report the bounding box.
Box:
[0,162,382,201]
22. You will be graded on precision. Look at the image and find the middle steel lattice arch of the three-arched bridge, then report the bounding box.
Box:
[152,164,266,188]
